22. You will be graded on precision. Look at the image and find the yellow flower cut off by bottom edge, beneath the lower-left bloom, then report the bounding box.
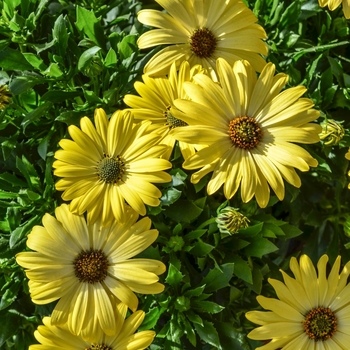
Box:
[29,309,155,350]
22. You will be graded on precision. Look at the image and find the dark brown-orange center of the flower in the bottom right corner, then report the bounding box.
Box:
[303,307,337,341]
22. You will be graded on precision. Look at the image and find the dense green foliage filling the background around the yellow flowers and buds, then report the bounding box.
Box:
[0,0,350,350]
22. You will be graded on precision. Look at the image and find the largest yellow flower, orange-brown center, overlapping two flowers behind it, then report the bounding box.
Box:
[172,59,321,207]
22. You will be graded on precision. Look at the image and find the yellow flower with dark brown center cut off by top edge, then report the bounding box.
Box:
[137,0,267,79]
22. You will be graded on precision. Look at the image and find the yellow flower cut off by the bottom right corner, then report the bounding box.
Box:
[246,255,350,350]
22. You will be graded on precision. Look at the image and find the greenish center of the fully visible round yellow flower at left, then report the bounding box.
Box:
[97,154,125,184]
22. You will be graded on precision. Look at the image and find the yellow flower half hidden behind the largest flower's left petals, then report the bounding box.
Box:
[124,61,202,159]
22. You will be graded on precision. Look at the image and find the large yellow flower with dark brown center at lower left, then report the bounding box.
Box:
[16,204,165,339]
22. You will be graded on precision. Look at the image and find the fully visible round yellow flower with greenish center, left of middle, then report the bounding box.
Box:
[53,109,171,224]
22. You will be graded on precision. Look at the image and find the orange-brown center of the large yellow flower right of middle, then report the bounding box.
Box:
[229,116,262,149]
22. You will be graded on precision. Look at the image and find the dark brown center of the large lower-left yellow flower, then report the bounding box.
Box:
[73,249,108,284]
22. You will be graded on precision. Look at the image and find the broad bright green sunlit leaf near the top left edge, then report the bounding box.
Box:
[76,6,106,48]
